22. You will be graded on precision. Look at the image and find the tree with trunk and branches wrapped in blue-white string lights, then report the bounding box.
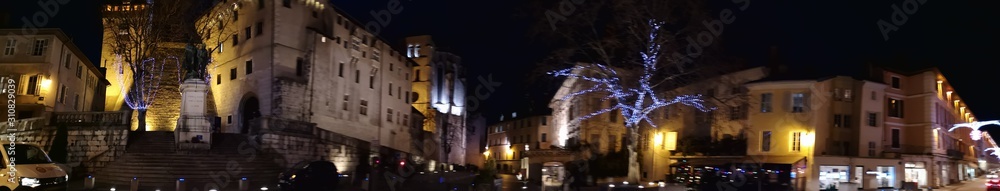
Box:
[549,20,715,181]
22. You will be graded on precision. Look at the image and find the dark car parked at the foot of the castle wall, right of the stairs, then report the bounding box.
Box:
[278,161,340,191]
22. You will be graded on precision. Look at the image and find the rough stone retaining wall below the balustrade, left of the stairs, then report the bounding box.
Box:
[0,127,128,175]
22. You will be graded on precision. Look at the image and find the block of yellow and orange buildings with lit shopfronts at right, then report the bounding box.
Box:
[746,66,983,190]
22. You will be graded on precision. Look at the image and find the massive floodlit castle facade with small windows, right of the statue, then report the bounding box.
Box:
[199,1,412,169]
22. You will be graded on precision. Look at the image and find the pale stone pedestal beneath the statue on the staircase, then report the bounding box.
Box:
[174,79,212,150]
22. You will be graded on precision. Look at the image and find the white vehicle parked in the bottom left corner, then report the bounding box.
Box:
[0,142,69,191]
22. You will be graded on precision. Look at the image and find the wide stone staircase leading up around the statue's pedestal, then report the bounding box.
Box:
[93,132,282,191]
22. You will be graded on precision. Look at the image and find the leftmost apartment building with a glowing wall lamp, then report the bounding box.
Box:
[0,28,109,119]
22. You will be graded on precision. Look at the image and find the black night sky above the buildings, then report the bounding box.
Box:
[0,0,1000,128]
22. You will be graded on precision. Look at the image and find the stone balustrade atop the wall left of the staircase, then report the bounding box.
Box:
[51,111,132,126]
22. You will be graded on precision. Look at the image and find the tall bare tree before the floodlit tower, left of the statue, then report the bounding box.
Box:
[103,0,184,131]
